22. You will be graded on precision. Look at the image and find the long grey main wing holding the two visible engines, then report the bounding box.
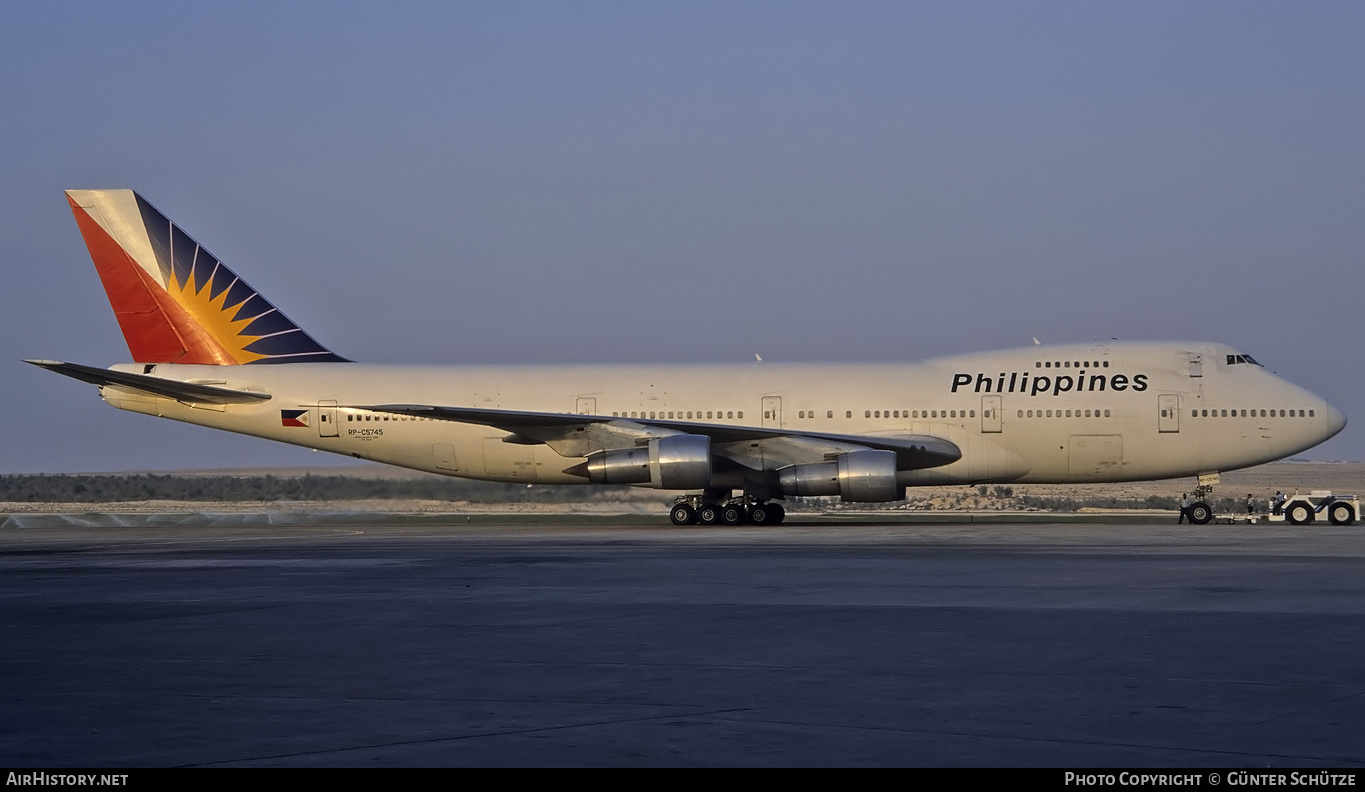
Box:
[352,404,962,470]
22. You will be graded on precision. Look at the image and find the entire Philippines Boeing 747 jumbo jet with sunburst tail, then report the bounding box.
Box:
[29,190,1346,524]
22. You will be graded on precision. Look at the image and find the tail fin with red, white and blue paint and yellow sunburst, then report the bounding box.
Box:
[67,190,345,365]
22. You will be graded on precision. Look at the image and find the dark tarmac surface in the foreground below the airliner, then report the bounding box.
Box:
[0,516,1365,767]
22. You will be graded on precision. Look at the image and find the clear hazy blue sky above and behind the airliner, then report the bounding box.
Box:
[0,1,1365,472]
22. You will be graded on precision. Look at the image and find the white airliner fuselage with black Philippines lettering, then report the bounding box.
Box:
[101,343,1345,485]
